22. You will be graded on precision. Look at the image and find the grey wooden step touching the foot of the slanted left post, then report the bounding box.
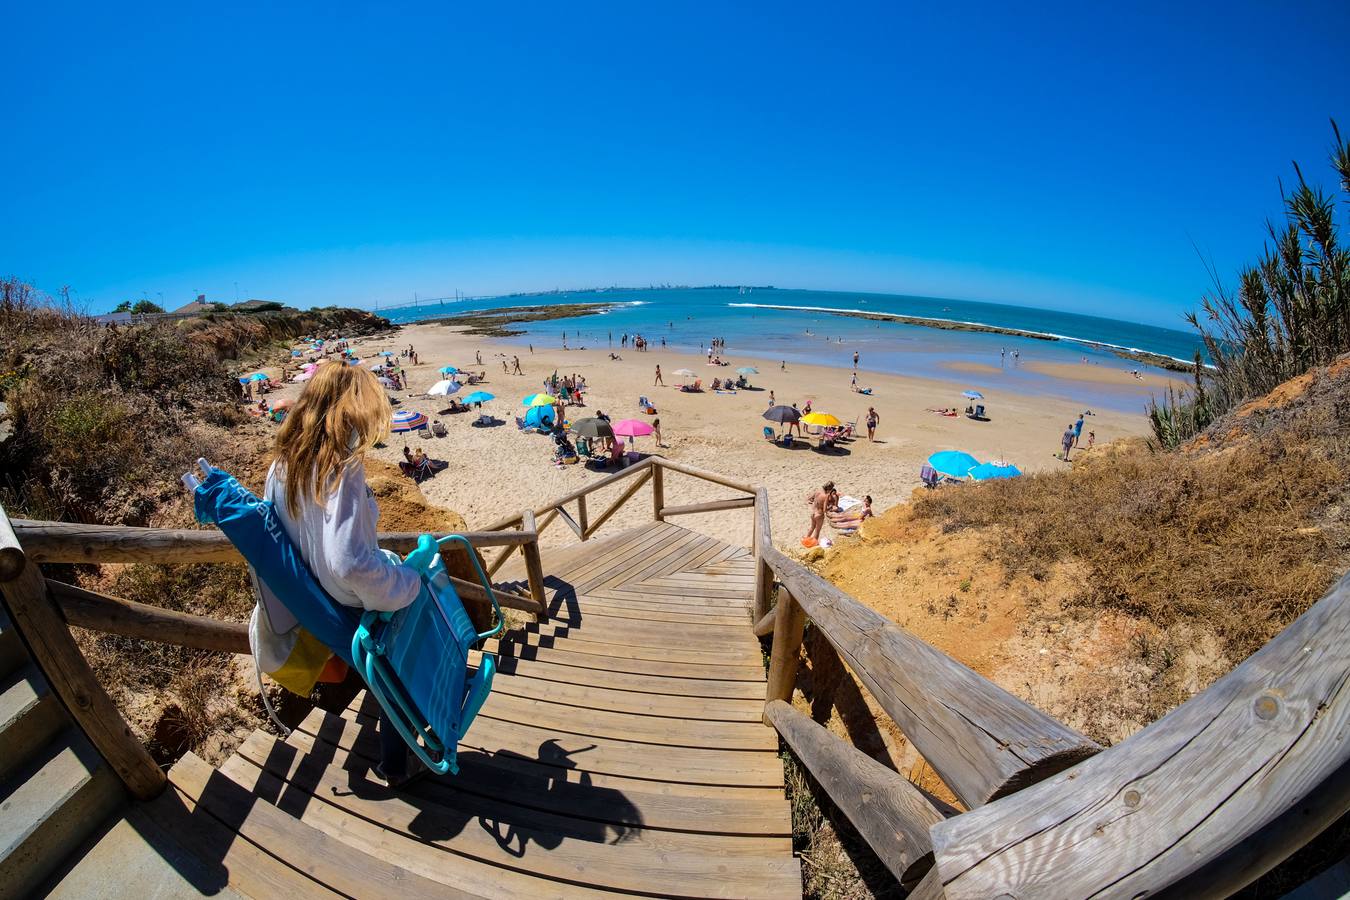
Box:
[0,727,124,899]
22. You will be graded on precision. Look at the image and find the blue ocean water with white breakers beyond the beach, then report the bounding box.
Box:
[379,287,1200,412]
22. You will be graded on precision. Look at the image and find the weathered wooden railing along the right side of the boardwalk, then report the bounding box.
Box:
[755,483,1350,900]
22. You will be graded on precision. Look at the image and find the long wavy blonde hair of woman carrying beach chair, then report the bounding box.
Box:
[273,362,394,517]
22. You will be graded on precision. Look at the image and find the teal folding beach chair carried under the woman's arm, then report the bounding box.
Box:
[351,534,506,775]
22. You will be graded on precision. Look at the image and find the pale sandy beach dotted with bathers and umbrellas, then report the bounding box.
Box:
[270,324,1148,548]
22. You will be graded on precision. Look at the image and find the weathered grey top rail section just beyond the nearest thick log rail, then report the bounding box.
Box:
[764,548,1100,808]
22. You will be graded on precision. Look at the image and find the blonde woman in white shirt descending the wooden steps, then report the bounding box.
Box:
[265,364,421,787]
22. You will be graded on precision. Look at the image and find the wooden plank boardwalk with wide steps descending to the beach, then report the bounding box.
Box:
[55,522,802,899]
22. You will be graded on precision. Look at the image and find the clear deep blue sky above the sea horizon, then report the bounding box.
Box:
[0,0,1350,325]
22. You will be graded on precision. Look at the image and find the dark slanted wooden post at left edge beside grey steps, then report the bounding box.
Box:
[0,509,165,800]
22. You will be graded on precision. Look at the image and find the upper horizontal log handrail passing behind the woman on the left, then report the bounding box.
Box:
[14,519,539,564]
